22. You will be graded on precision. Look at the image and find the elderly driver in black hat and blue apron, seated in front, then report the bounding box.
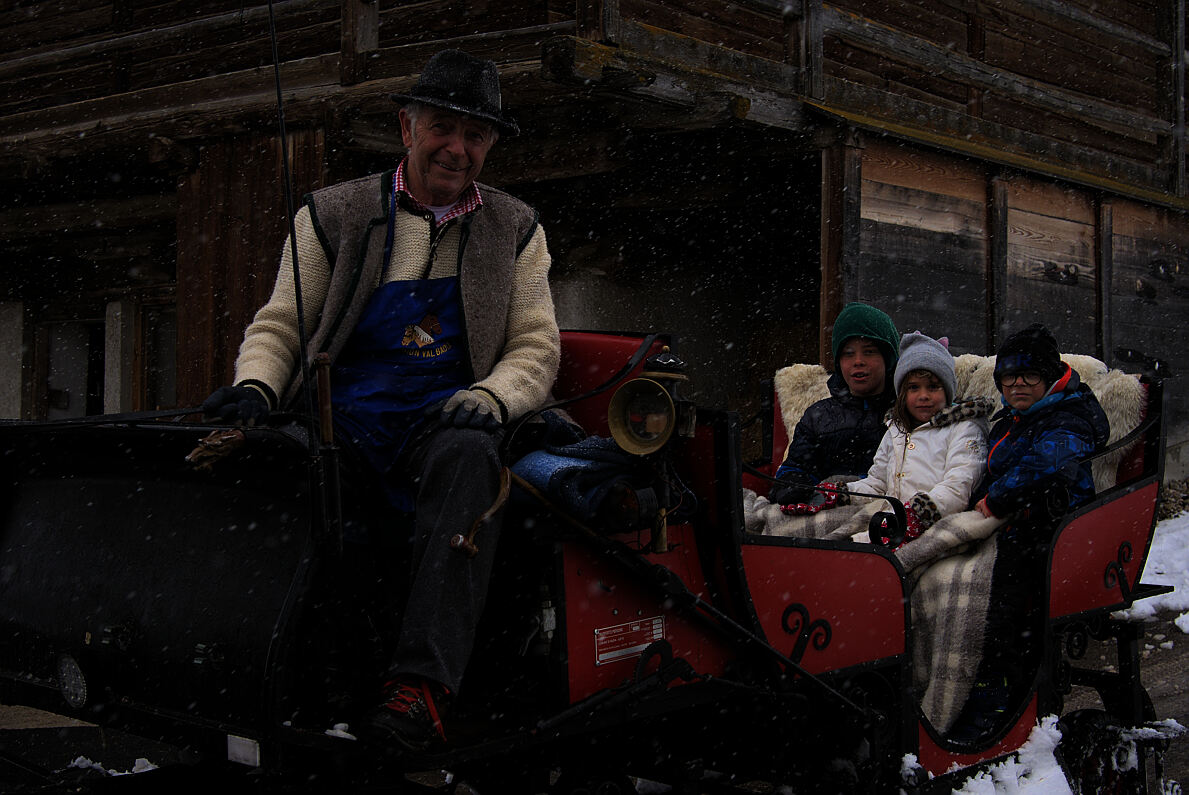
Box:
[203,50,560,751]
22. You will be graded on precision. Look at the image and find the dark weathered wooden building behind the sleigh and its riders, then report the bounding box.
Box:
[0,0,1189,474]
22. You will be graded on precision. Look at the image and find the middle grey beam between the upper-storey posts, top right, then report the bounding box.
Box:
[822,6,1172,135]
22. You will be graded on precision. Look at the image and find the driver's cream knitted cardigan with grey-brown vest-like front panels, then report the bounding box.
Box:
[235,171,561,421]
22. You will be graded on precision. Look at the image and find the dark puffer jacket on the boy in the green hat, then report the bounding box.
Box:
[768,371,895,505]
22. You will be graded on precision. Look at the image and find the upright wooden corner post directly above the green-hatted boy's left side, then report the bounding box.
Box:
[818,134,862,370]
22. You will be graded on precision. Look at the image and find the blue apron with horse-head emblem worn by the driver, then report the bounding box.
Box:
[331,190,471,512]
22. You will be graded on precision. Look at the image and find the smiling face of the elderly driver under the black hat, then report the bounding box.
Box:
[401,107,496,207]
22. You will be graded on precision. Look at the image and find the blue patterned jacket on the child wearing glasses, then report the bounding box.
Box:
[980,365,1111,516]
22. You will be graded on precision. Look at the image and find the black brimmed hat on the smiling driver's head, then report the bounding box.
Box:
[391,50,520,135]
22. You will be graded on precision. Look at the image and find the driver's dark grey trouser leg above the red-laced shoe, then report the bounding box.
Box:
[389,428,503,690]
